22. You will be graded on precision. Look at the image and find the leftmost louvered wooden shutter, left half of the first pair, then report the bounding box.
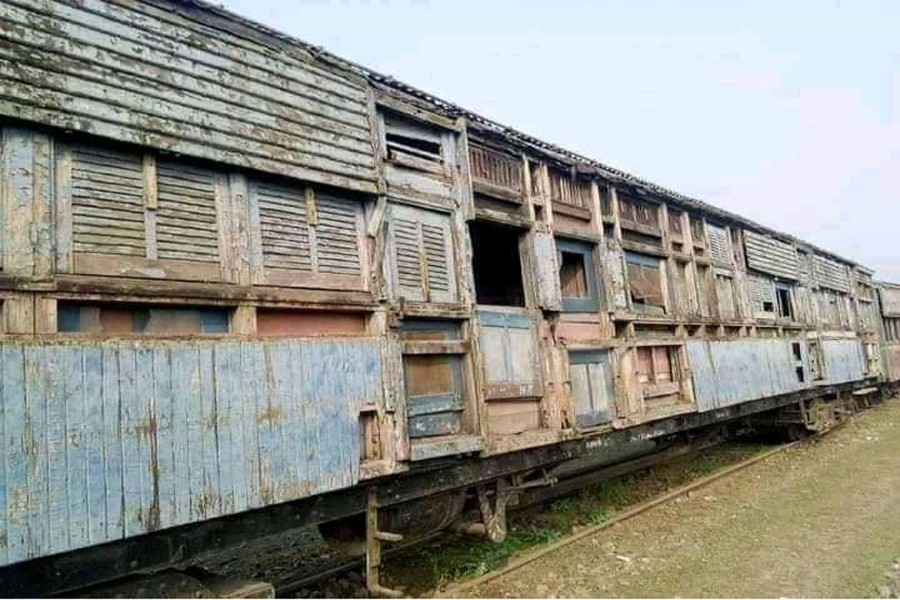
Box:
[71,145,146,257]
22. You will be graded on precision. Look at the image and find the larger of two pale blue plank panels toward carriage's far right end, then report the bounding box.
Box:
[685,339,808,411]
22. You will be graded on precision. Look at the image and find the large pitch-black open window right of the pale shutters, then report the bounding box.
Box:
[469,221,525,306]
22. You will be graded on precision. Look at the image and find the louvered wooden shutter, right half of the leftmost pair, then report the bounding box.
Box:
[156,162,220,263]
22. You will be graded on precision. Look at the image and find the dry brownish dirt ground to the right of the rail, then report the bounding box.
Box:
[463,398,900,598]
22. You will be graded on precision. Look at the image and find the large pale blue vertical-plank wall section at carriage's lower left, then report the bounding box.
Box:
[0,338,381,564]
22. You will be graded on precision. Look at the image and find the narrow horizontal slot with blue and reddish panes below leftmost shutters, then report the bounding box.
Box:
[56,302,231,336]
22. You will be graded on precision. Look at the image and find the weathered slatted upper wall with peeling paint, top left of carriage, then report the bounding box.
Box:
[0,0,375,192]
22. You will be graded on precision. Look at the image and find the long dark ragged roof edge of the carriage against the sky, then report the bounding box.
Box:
[172,0,874,272]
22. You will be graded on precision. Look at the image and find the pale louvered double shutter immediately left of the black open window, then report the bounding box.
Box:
[389,205,456,302]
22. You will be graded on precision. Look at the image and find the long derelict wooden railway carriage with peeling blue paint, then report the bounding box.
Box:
[0,0,888,592]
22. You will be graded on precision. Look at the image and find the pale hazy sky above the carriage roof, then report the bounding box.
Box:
[223,0,900,281]
